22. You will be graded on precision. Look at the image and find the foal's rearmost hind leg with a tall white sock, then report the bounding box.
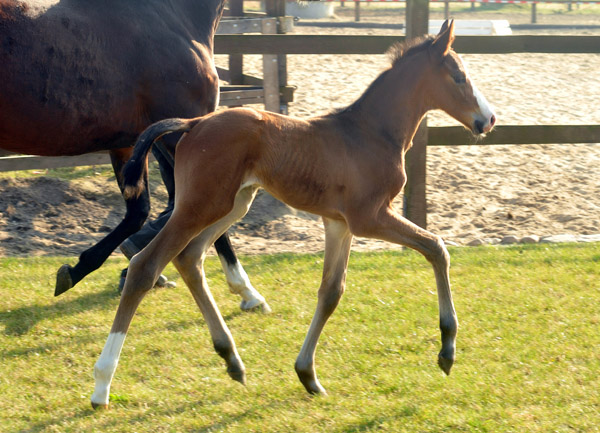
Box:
[91,214,197,408]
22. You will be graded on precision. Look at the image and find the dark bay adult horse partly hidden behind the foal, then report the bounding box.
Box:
[0,0,268,308]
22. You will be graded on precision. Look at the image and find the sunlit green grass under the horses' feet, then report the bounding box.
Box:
[0,244,600,432]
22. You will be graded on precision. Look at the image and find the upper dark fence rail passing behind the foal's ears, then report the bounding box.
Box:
[215,34,600,54]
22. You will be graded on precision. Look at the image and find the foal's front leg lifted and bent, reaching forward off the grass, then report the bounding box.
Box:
[352,209,458,374]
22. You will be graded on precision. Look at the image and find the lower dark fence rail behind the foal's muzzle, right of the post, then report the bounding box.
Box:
[428,125,600,146]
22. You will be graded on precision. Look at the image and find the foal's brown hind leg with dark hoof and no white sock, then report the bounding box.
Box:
[173,186,257,384]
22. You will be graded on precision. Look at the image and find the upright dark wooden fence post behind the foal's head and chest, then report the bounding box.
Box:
[404,0,429,228]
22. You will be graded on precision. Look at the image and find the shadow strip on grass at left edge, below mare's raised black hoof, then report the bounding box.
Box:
[0,289,118,336]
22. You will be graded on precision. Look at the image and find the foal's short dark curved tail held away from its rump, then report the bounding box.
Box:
[123,118,200,199]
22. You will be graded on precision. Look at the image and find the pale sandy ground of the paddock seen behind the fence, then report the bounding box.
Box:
[0,8,600,255]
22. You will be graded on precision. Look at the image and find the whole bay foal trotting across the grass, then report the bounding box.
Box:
[92,22,495,407]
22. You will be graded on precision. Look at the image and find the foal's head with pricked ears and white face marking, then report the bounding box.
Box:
[429,21,496,134]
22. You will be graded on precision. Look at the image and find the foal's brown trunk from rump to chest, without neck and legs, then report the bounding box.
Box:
[176,108,404,223]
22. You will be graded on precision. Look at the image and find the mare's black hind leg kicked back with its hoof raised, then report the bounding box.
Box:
[54,148,150,296]
